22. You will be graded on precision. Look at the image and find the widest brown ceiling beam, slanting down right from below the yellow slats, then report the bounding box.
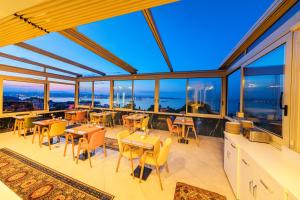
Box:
[59,28,137,74]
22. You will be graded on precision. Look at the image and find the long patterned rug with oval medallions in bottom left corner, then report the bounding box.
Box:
[0,148,114,200]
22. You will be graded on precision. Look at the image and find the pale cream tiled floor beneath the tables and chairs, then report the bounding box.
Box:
[0,127,235,200]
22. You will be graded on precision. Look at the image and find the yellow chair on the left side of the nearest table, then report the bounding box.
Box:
[116,130,143,178]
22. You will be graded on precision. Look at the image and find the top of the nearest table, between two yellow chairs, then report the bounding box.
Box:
[121,132,160,150]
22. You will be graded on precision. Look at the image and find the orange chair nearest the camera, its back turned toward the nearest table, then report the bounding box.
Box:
[76,129,106,168]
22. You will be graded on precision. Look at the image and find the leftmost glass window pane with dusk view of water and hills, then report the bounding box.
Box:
[3,80,45,113]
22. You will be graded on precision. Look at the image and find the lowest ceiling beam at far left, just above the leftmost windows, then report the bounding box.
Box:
[0,64,76,81]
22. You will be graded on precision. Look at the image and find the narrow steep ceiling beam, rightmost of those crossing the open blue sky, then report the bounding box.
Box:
[143,9,174,72]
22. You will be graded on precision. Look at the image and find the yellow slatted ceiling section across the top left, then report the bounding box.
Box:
[0,0,177,46]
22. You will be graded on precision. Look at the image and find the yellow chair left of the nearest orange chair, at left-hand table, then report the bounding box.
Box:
[40,121,67,150]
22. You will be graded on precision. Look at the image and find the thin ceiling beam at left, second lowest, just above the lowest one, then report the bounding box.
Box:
[0,52,81,77]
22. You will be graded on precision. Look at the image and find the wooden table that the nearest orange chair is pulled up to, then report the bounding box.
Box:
[64,124,104,160]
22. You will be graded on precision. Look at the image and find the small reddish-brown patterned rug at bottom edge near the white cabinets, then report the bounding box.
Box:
[174,182,226,200]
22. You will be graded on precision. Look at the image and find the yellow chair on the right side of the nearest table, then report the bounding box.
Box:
[140,138,172,190]
